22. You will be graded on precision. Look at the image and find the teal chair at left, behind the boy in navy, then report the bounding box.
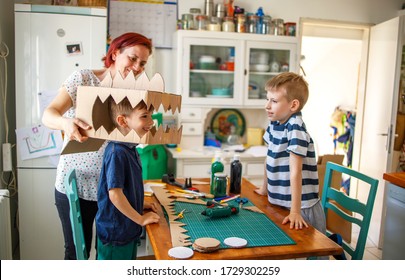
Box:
[65,169,88,260]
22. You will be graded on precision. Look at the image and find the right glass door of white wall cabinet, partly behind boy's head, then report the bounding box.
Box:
[243,42,298,106]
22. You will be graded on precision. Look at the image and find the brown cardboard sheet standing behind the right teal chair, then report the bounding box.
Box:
[317,155,352,243]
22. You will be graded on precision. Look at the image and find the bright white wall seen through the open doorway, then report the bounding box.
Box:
[301,37,362,158]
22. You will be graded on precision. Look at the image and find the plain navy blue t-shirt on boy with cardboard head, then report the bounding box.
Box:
[96,142,144,246]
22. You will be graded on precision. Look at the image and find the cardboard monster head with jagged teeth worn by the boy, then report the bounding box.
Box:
[61,72,182,154]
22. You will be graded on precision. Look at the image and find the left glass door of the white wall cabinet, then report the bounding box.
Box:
[182,38,243,107]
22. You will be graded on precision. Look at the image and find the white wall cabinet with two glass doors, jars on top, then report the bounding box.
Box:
[176,30,298,108]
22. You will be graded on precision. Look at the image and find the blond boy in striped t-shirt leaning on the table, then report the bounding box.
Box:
[255,72,326,233]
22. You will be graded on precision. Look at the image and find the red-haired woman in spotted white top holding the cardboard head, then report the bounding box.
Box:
[42,33,152,259]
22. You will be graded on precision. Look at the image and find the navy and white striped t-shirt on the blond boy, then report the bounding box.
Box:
[263,113,319,209]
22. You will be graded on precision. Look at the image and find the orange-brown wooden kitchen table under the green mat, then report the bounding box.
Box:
[145,178,343,260]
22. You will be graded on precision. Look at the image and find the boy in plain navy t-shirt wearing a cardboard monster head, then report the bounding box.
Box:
[96,98,159,260]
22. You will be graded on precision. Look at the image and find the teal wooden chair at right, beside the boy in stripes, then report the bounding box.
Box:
[322,162,378,260]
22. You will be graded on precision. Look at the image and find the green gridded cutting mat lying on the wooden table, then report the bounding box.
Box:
[170,202,296,248]
